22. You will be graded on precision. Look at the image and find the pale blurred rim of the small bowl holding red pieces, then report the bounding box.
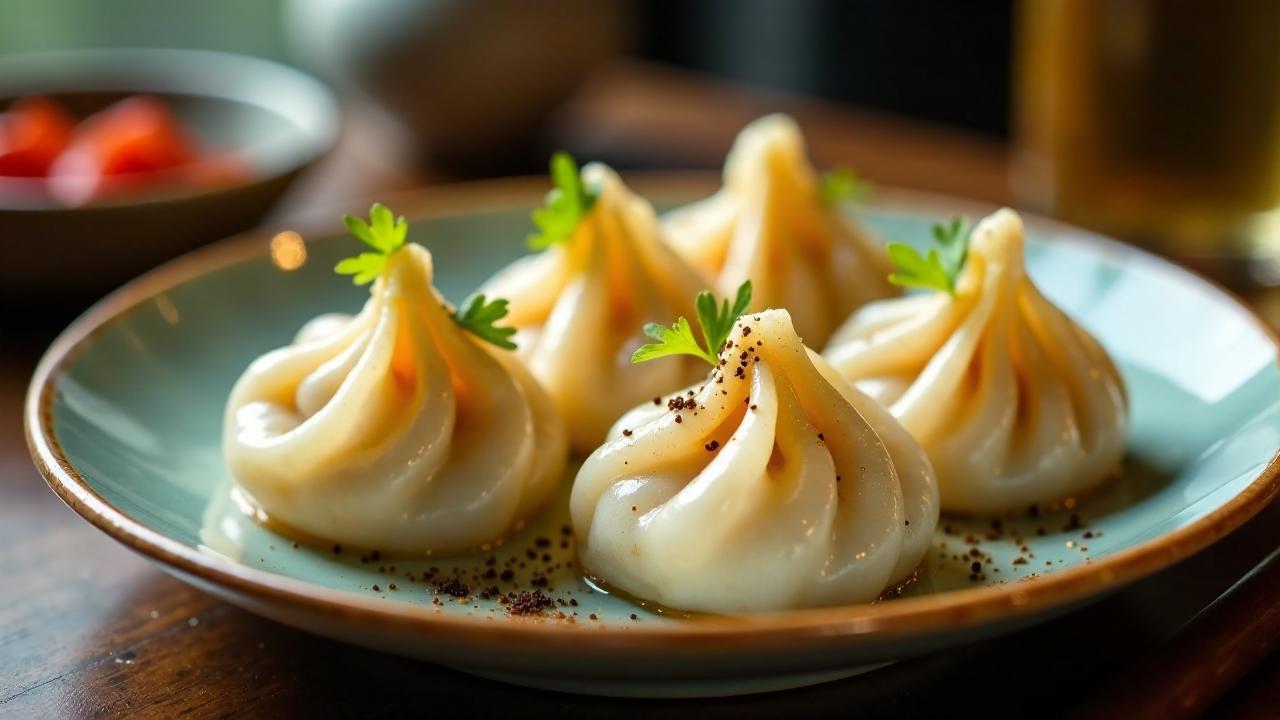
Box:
[0,47,342,213]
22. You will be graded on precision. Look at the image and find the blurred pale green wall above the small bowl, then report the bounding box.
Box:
[0,0,288,60]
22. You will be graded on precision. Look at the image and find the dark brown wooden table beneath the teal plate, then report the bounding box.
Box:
[0,65,1280,717]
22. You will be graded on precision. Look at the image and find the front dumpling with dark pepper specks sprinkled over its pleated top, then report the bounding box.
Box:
[570,310,938,612]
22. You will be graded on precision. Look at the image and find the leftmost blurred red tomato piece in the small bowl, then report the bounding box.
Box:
[0,97,76,178]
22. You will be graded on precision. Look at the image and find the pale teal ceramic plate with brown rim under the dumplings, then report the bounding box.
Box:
[27,177,1280,697]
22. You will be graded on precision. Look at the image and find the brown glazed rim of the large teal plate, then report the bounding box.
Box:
[23,172,1280,652]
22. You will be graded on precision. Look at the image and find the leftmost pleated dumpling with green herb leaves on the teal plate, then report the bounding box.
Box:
[223,245,567,552]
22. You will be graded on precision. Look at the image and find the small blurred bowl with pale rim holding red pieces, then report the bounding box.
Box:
[0,49,339,296]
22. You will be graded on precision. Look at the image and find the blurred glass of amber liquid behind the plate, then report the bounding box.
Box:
[1015,0,1280,284]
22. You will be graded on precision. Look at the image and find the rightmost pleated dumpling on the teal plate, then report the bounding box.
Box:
[824,209,1128,512]
